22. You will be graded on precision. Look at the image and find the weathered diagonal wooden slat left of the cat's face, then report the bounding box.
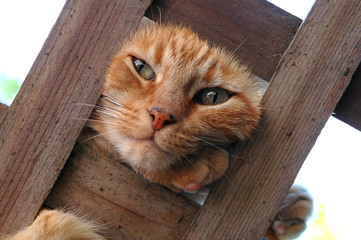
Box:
[0,0,150,232]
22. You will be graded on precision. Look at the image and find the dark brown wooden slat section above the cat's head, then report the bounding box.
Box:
[146,0,301,81]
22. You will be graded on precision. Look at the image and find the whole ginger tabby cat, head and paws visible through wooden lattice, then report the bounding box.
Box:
[2,24,312,240]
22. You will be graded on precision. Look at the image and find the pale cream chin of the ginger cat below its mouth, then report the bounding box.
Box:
[117,138,178,171]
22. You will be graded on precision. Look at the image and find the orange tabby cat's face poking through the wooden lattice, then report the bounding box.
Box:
[91,24,260,170]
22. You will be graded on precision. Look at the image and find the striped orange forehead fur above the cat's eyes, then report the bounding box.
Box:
[124,24,250,92]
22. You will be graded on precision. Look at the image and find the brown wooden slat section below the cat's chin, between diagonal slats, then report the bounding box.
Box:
[45,142,199,240]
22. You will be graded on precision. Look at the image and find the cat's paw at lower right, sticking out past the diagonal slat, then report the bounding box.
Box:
[270,185,313,240]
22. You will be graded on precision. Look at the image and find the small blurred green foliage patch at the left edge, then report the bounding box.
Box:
[0,73,21,105]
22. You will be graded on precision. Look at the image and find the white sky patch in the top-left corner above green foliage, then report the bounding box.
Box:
[0,0,65,79]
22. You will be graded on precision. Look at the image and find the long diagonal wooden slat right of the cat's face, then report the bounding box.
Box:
[185,0,361,240]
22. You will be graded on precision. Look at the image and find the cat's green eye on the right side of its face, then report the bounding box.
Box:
[195,87,232,105]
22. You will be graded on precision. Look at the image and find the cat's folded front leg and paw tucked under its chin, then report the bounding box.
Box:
[135,149,228,192]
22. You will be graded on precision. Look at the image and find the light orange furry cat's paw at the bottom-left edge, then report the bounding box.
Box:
[10,210,105,240]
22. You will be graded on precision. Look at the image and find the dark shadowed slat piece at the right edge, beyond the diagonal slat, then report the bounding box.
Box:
[334,65,361,131]
